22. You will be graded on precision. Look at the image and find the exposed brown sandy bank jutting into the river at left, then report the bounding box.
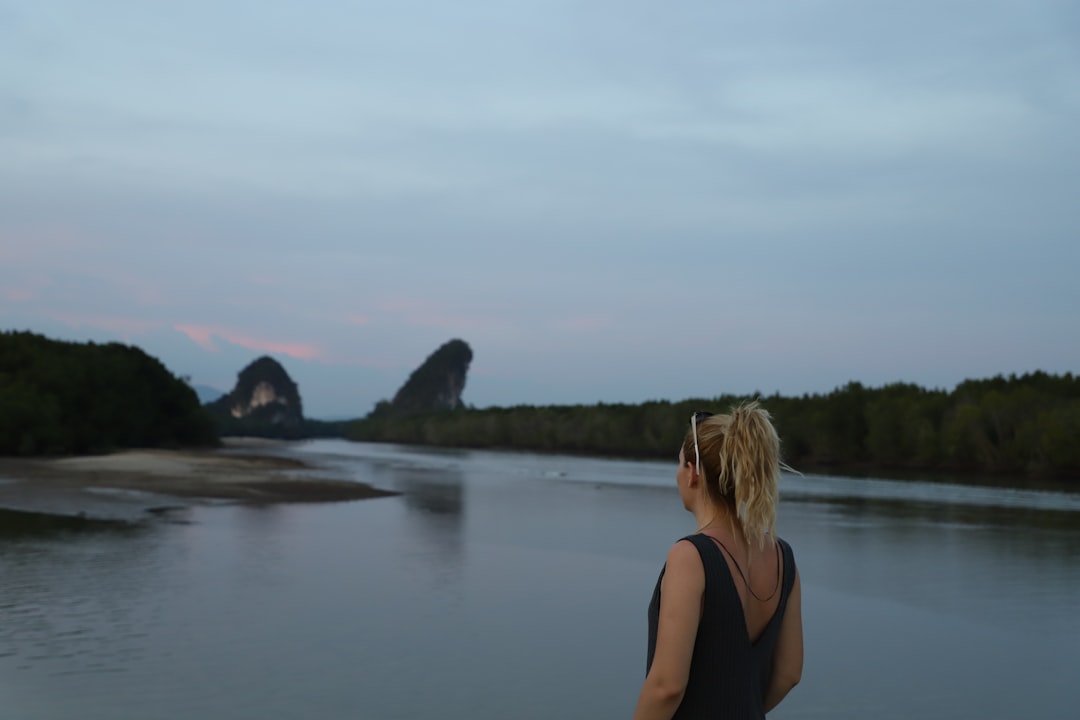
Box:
[0,444,395,515]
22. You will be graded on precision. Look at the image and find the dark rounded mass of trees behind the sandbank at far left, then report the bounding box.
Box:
[0,332,218,456]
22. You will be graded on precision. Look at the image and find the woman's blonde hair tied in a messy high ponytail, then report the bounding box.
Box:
[683,402,784,547]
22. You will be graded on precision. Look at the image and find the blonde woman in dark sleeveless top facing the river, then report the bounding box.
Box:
[634,403,802,720]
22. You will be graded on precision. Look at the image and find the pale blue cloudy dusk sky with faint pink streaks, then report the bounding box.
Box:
[0,0,1080,418]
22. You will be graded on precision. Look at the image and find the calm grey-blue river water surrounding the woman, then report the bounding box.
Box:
[0,440,1080,720]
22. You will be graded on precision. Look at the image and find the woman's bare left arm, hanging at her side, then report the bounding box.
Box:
[634,542,705,720]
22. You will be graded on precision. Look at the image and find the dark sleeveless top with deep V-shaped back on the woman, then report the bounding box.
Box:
[646,534,795,720]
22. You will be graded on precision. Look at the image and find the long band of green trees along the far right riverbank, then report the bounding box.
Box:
[350,372,1080,479]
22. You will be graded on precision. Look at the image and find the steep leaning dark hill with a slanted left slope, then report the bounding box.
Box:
[382,339,472,415]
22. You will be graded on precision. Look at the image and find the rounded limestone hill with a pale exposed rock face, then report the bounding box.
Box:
[206,355,303,436]
